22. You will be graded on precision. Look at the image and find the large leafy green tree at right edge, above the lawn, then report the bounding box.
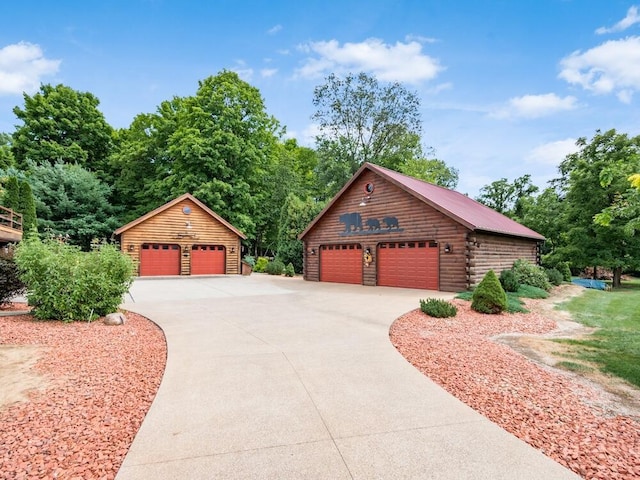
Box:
[559,129,640,287]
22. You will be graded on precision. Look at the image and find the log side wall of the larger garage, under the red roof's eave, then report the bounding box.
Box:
[467,233,539,287]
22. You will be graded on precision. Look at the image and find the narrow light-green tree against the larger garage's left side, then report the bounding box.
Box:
[278,193,323,273]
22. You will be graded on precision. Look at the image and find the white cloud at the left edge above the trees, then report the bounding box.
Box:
[0,42,61,95]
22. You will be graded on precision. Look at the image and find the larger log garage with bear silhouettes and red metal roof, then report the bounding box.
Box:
[300,163,544,292]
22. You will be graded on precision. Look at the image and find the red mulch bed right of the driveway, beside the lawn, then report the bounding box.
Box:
[390,300,640,480]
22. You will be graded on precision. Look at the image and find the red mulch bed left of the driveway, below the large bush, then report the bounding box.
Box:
[0,313,167,480]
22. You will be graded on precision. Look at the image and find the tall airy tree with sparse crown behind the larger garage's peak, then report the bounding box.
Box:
[312,73,422,197]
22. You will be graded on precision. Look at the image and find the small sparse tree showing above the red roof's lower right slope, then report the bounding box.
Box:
[476,174,538,219]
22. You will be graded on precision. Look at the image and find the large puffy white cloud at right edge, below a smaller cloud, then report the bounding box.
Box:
[559,37,640,101]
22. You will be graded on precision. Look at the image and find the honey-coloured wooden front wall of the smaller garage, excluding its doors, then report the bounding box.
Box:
[120,199,241,275]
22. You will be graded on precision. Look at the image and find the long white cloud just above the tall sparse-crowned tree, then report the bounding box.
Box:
[296,38,444,83]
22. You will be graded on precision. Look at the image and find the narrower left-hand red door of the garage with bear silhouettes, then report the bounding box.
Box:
[320,243,362,284]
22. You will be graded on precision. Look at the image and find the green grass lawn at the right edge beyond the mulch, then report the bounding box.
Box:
[558,279,640,387]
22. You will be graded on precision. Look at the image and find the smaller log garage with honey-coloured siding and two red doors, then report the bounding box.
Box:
[115,193,246,276]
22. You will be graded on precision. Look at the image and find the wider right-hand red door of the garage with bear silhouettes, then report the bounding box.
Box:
[378,242,438,290]
